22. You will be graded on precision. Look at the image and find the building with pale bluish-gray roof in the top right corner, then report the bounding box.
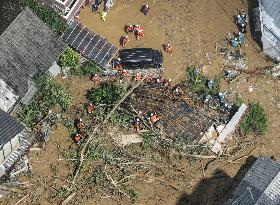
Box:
[252,0,280,61]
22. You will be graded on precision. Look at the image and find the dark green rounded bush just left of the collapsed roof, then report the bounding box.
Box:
[88,82,124,105]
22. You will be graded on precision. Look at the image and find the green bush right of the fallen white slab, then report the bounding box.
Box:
[240,103,267,135]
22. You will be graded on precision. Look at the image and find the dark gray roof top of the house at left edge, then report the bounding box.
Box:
[0,109,24,148]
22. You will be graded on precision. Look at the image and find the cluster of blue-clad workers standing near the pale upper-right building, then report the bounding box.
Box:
[229,11,248,48]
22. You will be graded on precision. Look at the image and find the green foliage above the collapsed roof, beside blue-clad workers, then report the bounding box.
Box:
[186,66,220,97]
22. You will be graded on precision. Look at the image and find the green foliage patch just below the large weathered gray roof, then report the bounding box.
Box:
[18,75,72,127]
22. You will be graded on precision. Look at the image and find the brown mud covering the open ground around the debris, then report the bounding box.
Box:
[1,0,280,205]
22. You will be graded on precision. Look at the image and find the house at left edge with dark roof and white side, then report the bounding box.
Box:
[0,108,31,177]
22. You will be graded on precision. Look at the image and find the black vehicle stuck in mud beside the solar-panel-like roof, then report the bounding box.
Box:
[119,48,163,69]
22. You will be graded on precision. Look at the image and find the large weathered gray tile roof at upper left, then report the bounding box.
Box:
[0,8,66,98]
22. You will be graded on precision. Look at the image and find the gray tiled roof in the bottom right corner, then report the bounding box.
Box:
[226,157,280,205]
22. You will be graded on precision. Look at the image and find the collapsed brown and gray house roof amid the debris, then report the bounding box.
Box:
[122,83,229,143]
